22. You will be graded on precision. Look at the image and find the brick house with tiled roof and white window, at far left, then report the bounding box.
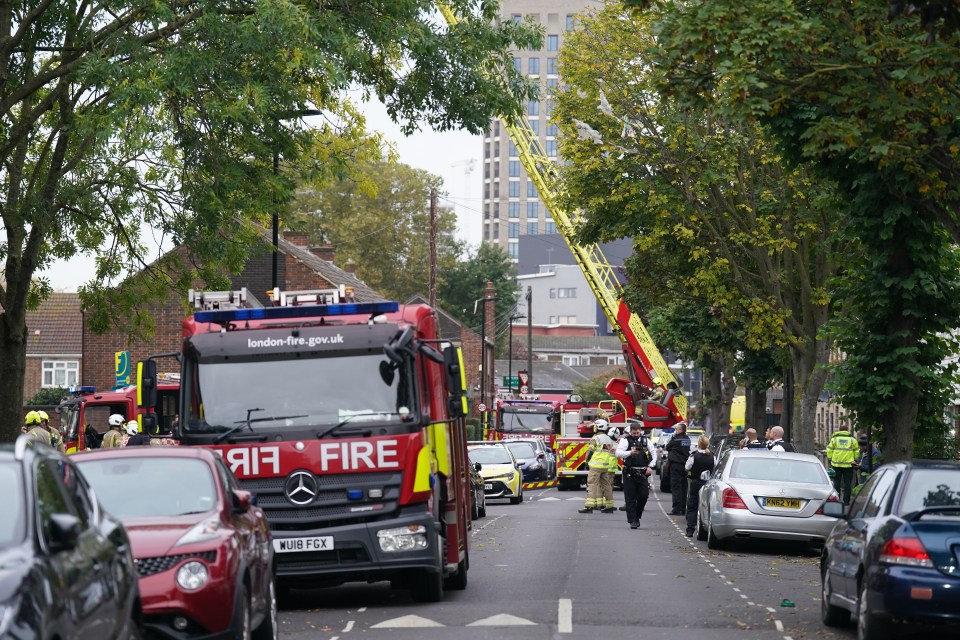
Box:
[23,293,83,402]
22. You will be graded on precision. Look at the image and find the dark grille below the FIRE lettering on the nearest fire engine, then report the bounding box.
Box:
[240,472,403,528]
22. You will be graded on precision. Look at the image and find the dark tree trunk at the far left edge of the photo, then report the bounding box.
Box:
[0,312,27,442]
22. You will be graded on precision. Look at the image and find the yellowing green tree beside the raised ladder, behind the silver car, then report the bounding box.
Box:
[555,5,843,451]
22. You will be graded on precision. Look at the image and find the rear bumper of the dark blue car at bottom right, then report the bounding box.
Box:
[867,565,960,623]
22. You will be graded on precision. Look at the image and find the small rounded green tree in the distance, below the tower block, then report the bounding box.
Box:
[437,242,520,344]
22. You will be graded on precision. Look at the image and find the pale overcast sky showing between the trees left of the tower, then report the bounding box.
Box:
[44,97,483,291]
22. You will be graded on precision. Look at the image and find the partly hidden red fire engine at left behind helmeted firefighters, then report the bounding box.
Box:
[57,374,180,453]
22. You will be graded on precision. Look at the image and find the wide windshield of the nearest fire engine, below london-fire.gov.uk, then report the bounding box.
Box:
[181,350,417,433]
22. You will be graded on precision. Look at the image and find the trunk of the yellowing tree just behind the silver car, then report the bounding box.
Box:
[790,339,832,453]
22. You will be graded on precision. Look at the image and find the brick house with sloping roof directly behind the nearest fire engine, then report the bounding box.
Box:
[81,229,383,389]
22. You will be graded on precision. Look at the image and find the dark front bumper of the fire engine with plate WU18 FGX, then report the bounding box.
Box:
[273,509,442,586]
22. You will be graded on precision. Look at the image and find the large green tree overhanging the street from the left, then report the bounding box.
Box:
[0,0,541,440]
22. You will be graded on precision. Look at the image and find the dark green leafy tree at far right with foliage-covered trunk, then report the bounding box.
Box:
[646,0,960,460]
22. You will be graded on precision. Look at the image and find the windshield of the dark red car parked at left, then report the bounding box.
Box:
[77,456,217,520]
